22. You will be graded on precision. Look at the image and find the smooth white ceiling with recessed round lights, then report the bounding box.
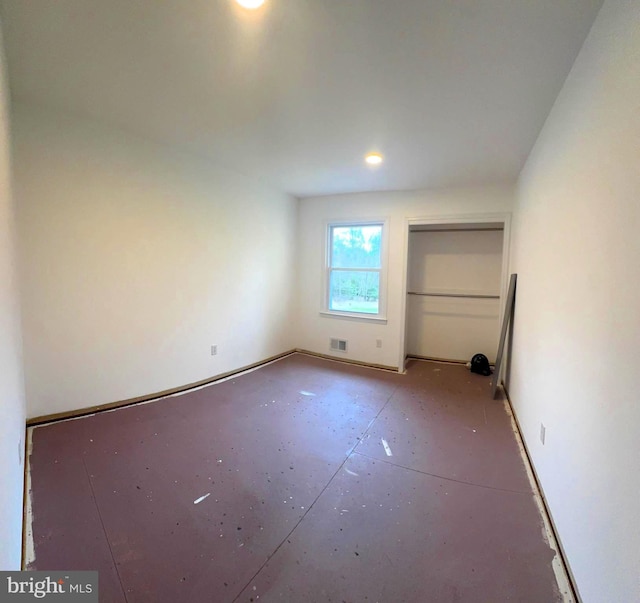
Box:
[0,0,602,197]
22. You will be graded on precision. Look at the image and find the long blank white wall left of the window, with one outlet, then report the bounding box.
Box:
[13,105,297,417]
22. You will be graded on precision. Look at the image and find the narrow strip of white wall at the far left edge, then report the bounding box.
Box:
[0,23,25,570]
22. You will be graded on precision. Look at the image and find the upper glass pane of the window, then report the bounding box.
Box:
[331,224,382,268]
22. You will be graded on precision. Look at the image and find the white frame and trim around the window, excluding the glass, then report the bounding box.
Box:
[320,218,389,323]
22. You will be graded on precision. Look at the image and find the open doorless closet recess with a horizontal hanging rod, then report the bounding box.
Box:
[401,217,509,367]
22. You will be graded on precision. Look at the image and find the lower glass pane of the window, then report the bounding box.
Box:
[329,270,380,314]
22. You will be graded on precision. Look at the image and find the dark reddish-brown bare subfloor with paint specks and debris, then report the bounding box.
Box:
[26,354,561,603]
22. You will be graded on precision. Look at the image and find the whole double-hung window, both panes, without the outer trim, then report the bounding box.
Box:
[326,222,384,316]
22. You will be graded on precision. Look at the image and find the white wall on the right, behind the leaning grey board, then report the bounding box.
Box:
[508,0,640,603]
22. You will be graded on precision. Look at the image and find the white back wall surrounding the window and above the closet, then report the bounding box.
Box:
[296,186,515,367]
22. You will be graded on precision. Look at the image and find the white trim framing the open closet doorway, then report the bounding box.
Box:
[398,212,511,373]
